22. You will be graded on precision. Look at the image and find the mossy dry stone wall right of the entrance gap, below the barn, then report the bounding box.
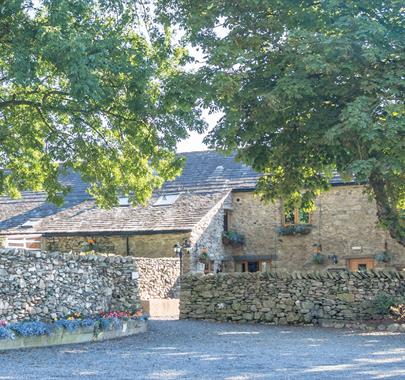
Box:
[180,271,405,325]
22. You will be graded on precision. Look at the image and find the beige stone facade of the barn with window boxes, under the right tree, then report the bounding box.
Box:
[230,186,405,270]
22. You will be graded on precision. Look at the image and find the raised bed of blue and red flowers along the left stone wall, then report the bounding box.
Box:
[0,310,147,350]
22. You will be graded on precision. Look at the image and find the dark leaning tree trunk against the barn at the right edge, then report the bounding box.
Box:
[369,174,405,246]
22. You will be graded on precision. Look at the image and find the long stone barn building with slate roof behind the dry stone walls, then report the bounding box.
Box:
[0,151,405,272]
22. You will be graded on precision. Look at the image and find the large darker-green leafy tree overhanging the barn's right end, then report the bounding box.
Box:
[161,0,405,245]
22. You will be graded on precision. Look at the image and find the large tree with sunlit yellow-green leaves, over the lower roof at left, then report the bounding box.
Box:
[0,0,202,207]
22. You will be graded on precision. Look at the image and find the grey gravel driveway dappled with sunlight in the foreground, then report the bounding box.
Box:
[0,320,405,380]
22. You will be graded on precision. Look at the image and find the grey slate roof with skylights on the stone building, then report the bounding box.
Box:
[0,151,348,235]
